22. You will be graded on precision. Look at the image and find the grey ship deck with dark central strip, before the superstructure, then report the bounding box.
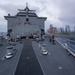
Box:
[0,38,75,75]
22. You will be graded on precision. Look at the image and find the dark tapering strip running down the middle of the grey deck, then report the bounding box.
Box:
[15,40,44,75]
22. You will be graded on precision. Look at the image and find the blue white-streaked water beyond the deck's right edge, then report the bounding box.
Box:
[56,37,75,57]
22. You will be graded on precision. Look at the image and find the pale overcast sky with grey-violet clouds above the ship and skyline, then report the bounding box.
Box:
[0,0,75,32]
